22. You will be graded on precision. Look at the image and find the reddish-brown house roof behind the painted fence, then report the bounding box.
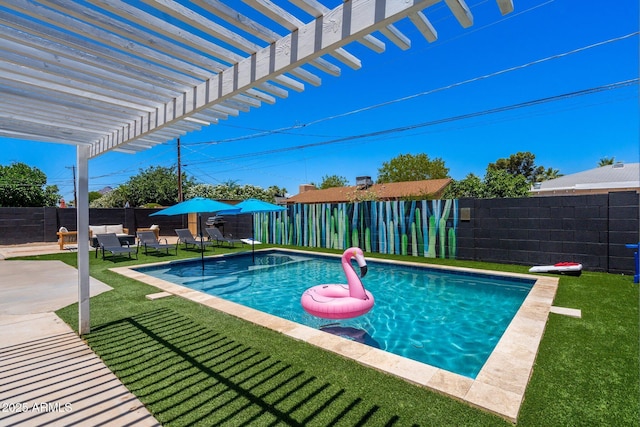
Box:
[287,178,451,204]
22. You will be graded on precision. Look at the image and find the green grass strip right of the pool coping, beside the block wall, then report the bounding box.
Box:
[520,272,640,426]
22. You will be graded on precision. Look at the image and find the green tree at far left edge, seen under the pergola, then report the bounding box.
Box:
[0,162,61,207]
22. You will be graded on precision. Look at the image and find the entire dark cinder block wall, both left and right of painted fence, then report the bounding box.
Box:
[0,196,640,274]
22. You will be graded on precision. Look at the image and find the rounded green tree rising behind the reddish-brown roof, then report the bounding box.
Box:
[377,153,449,184]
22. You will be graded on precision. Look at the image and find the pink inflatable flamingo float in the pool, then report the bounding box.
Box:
[300,248,374,319]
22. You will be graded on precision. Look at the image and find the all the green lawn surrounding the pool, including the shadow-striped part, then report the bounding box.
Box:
[11,249,640,426]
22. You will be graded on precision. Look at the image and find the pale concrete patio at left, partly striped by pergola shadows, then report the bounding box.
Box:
[0,256,159,426]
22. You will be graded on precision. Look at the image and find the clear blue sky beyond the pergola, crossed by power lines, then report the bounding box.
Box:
[0,0,640,200]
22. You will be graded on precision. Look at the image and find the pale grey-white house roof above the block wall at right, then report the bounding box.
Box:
[531,163,640,194]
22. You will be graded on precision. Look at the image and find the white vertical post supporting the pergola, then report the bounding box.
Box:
[76,145,91,335]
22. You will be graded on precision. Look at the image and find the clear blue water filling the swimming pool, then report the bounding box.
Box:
[137,251,534,378]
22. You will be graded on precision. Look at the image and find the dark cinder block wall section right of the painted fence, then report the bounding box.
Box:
[458,192,639,274]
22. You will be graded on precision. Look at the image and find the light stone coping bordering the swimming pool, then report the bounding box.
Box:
[109,248,559,423]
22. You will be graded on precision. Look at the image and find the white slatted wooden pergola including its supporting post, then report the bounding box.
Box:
[0,0,513,334]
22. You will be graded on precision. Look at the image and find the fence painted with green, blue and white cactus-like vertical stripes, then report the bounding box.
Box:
[254,200,458,258]
